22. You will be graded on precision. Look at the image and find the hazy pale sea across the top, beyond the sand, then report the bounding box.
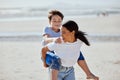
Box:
[0,0,120,21]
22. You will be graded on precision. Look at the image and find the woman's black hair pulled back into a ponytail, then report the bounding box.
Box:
[62,20,90,46]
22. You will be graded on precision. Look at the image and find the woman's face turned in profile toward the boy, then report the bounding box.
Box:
[61,27,74,42]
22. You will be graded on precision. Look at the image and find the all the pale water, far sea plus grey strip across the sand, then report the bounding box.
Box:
[0,0,120,41]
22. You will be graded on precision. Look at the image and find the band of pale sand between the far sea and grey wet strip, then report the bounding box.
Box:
[0,14,120,34]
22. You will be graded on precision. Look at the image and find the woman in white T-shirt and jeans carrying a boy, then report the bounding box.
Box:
[42,20,95,80]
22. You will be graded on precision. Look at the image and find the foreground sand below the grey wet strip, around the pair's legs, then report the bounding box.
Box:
[0,42,120,80]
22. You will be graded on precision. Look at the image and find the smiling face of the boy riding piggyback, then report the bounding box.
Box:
[50,15,62,29]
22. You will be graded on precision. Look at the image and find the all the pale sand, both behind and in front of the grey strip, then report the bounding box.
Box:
[0,15,120,80]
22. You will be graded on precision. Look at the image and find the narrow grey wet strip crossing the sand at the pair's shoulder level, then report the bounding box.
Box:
[0,32,120,42]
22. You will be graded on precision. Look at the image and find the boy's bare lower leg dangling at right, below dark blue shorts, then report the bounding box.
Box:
[78,52,99,80]
